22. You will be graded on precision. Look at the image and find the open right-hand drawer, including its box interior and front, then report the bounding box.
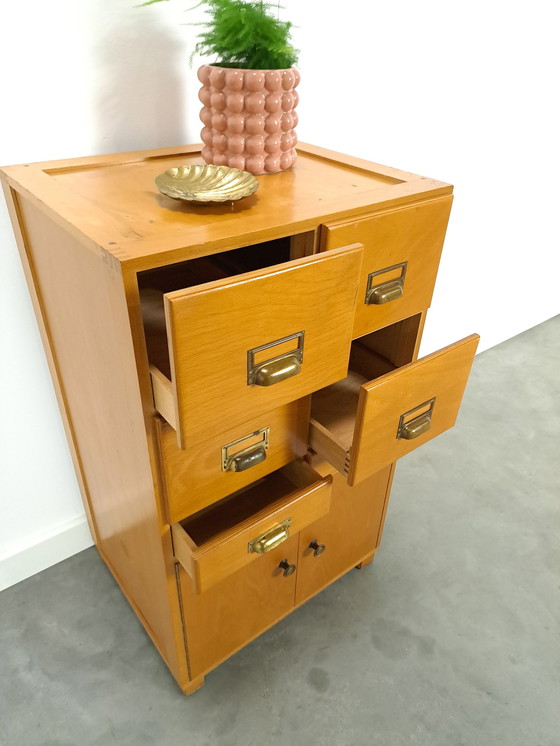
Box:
[309,330,479,485]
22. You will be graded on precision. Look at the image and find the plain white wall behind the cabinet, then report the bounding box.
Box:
[0,0,560,588]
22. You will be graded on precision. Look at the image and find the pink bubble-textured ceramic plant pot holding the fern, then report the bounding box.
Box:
[198,65,300,174]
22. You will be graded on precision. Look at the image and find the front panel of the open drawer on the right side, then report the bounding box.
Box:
[348,334,479,485]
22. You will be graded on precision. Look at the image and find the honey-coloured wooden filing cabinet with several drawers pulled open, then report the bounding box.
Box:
[1,145,478,693]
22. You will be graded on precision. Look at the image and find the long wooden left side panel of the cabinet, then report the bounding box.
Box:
[17,198,185,675]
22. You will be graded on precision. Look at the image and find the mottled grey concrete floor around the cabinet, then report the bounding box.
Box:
[0,316,560,746]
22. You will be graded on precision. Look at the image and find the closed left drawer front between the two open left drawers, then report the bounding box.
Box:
[157,397,309,523]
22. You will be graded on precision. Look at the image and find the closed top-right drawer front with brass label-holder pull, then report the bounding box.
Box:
[322,196,453,338]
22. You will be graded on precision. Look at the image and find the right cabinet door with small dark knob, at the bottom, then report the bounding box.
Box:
[296,464,392,605]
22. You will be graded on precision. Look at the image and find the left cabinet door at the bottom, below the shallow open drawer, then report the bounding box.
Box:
[180,534,299,678]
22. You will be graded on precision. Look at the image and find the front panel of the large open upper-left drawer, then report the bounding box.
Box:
[165,246,362,448]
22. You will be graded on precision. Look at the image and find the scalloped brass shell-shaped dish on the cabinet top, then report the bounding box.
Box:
[156,165,259,202]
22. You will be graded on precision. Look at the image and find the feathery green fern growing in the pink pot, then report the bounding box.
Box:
[143,0,298,70]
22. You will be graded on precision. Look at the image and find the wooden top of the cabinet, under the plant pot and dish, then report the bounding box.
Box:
[0,143,452,271]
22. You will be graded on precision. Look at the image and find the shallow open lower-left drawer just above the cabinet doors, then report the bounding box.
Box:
[171,461,332,593]
